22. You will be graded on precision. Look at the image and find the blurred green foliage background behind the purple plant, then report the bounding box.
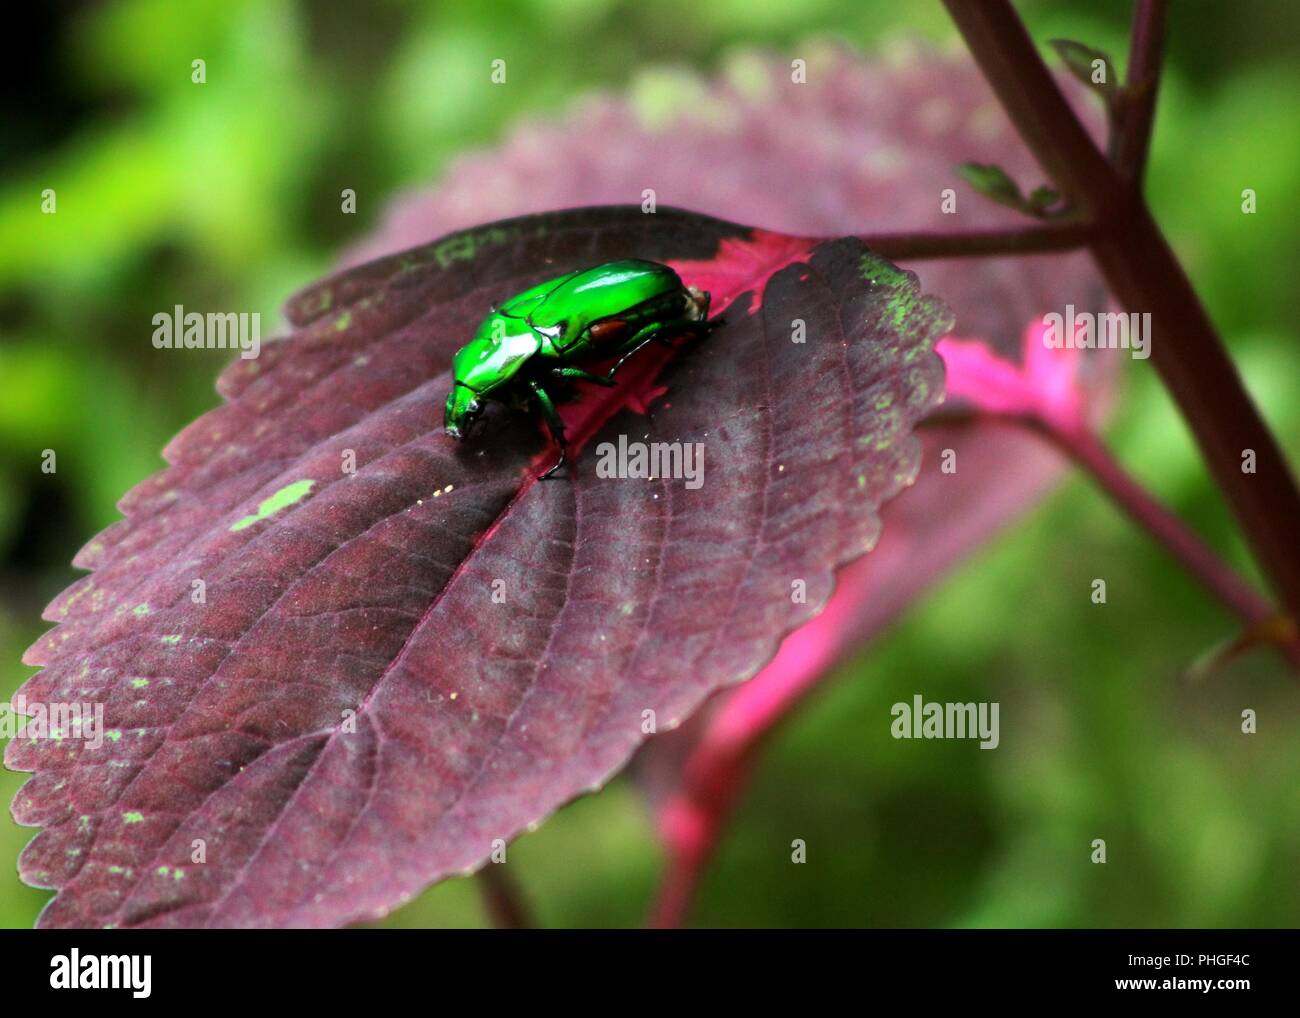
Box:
[0,0,1300,926]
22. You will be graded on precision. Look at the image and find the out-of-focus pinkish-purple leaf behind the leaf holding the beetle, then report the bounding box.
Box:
[338,46,1115,854]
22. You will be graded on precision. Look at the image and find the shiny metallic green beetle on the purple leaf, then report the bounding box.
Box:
[443,259,711,478]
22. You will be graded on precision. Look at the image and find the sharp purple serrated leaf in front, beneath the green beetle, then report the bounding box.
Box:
[5,208,950,926]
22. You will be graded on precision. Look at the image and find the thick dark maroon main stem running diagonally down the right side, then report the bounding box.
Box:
[944,0,1300,629]
